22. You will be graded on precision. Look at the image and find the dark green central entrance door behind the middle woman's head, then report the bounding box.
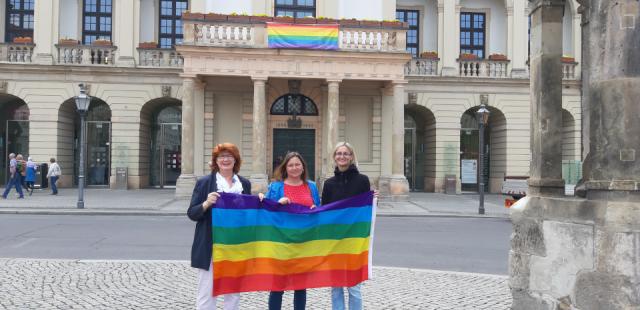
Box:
[272,129,316,180]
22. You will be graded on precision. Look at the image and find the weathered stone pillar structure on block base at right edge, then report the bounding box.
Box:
[509,0,640,310]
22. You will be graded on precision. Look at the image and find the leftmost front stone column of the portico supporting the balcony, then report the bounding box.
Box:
[176,77,196,197]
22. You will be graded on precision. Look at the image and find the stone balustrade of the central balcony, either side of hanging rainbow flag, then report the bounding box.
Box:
[183,20,407,52]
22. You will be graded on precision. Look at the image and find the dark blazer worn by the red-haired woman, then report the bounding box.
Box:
[187,173,251,270]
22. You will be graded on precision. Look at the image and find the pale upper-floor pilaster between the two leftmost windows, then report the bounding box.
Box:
[32,0,60,65]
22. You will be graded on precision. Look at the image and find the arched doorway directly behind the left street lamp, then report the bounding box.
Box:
[58,97,111,187]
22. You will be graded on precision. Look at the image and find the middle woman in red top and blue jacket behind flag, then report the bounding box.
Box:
[258,152,320,310]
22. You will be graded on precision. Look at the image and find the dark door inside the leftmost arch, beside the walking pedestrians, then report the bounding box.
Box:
[0,120,29,184]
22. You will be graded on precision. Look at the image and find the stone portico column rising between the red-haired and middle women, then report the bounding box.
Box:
[250,77,269,193]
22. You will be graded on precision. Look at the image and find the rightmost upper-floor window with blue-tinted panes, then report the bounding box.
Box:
[460,13,485,59]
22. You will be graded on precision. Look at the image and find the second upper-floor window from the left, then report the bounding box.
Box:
[82,0,112,44]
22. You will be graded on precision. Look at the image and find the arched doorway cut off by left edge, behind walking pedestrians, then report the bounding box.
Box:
[0,95,29,185]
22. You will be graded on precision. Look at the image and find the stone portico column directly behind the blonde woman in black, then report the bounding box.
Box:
[325,80,341,178]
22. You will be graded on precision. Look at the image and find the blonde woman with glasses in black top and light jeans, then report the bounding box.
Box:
[322,142,371,310]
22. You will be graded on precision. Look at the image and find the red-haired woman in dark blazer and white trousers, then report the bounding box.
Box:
[187,143,251,310]
